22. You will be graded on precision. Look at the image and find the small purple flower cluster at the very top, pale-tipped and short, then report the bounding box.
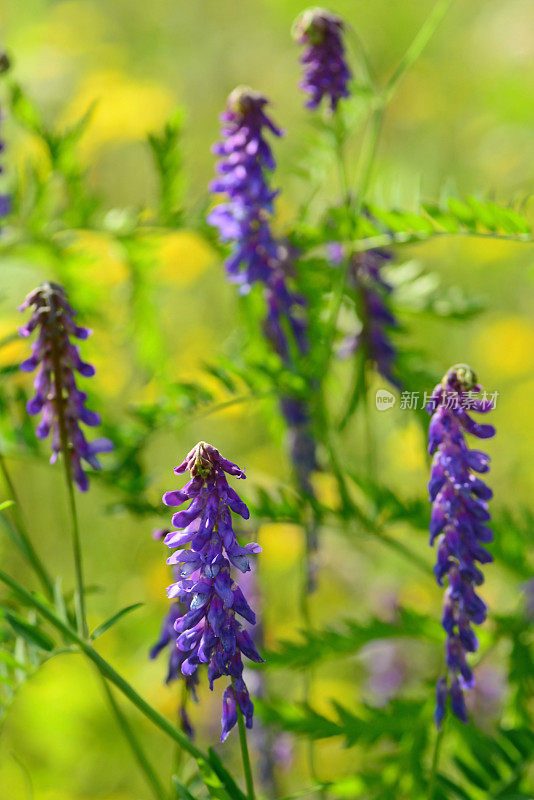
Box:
[293,8,352,111]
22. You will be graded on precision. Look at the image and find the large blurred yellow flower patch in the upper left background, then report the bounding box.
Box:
[62,69,176,158]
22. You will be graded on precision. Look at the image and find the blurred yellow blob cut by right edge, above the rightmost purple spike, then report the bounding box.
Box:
[473,316,534,376]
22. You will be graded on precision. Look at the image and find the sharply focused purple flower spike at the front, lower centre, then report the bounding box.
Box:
[163,442,262,741]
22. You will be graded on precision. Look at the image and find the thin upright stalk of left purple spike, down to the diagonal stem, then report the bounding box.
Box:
[52,340,89,637]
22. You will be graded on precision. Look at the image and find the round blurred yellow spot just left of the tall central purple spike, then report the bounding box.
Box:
[158,231,215,286]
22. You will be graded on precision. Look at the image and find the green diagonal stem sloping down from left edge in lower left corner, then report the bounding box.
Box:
[0,570,209,763]
